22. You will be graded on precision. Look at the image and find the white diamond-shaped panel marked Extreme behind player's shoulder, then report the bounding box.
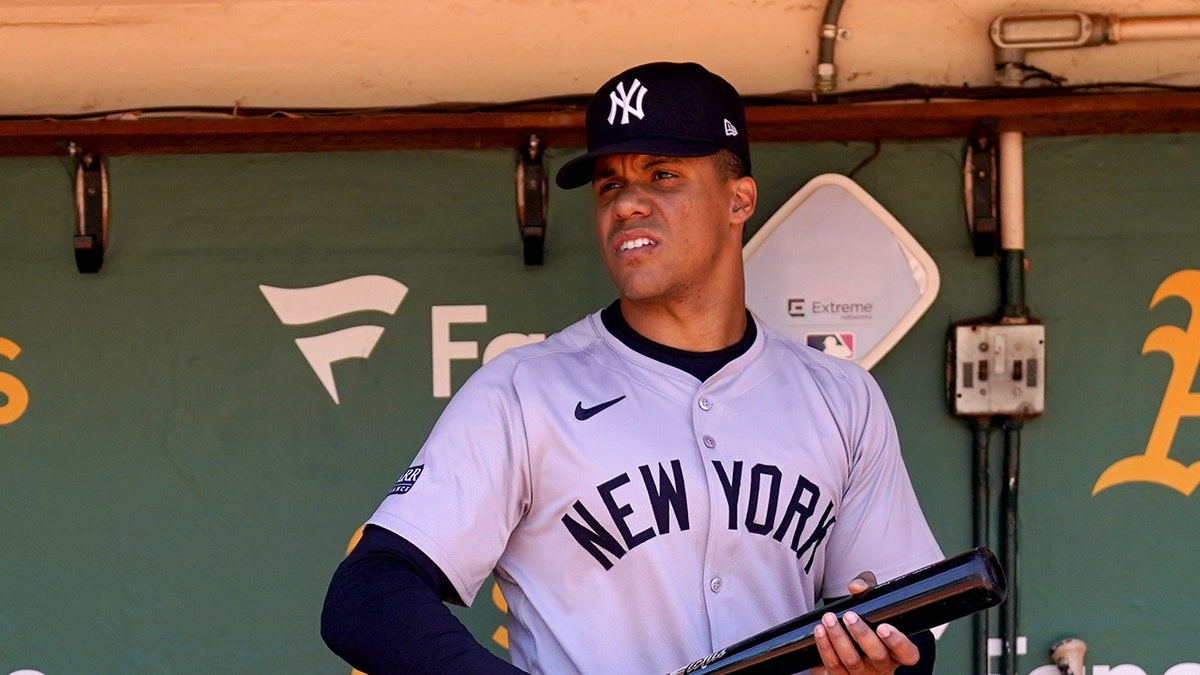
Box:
[743,174,940,369]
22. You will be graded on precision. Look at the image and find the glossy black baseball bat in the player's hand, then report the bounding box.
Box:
[670,546,1007,675]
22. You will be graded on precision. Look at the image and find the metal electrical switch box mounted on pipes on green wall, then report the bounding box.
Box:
[946,323,1046,418]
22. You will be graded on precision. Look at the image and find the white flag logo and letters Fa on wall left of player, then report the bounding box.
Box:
[258,275,546,404]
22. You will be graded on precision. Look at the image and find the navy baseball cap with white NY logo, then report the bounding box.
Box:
[554,61,750,190]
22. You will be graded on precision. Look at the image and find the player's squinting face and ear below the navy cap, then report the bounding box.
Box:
[592,155,755,303]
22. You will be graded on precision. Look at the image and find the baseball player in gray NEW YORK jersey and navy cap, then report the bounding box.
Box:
[322,62,942,675]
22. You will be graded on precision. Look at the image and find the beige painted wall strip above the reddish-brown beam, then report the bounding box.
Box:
[0,0,1200,115]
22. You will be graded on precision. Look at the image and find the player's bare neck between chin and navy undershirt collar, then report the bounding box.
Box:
[620,297,746,352]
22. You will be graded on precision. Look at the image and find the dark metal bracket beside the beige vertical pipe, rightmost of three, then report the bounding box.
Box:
[962,119,1000,257]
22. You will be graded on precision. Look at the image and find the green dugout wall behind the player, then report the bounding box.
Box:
[0,135,1200,675]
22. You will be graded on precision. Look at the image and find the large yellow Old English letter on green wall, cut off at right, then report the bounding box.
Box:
[1092,269,1200,495]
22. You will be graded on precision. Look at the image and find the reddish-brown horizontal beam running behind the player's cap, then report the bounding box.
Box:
[0,91,1200,156]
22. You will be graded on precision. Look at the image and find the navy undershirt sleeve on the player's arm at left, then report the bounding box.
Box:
[320,525,522,675]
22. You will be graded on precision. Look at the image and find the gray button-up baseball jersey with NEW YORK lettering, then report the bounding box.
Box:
[371,312,942,674]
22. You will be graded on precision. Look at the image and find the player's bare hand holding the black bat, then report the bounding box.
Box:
[812,572,920,675]
